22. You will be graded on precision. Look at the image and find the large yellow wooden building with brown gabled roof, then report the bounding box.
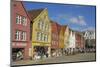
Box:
[28,8,51,58]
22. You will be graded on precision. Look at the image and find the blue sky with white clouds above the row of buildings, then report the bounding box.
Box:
[23,2,96,31]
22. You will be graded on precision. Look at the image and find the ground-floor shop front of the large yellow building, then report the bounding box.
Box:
[32,44,50,60]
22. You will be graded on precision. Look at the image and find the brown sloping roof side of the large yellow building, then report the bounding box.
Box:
[28,8,44,20]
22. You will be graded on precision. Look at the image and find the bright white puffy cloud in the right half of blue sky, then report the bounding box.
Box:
[69,16,86,26]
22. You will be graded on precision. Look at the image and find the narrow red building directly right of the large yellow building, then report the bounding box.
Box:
[51,21,59,56]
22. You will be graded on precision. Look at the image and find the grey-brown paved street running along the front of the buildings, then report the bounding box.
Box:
[12,53,95,65]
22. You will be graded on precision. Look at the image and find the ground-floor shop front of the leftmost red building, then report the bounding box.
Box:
[12,42,29,61]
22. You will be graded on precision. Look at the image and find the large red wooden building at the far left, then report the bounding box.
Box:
[11,0,31,60]
